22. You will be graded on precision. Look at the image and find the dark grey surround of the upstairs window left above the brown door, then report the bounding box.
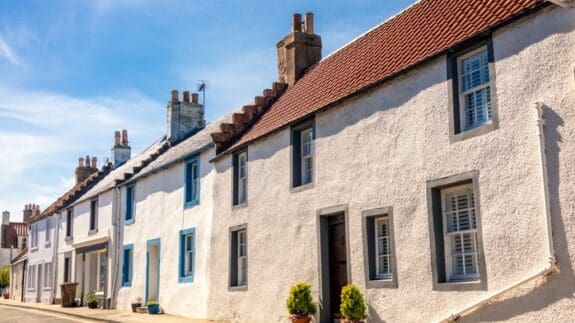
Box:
[290,119,316,192]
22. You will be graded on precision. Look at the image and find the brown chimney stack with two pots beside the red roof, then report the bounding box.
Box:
[276,12,321,85]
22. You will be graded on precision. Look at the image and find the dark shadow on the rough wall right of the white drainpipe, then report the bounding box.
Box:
[461,91,575,322]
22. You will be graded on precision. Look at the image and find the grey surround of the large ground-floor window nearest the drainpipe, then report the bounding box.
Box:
[427,170,487,291]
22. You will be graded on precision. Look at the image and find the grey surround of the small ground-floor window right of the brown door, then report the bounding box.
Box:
[361,206,398,288]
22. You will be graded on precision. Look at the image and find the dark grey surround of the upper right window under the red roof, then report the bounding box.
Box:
[447,35,499,143]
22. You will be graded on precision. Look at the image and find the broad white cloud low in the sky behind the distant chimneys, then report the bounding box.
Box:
[0,87,165,219]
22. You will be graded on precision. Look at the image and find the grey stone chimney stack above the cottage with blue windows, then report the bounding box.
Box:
[167,90,206,143]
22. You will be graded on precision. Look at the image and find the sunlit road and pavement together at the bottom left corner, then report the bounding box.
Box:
[0,299,223,323]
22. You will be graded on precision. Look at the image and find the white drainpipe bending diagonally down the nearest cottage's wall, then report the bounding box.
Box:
[440,102,557,322]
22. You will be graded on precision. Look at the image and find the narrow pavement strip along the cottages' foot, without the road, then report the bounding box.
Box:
[0,299,220,323]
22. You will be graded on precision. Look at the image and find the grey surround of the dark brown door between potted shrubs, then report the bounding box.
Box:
[317,204,351,322]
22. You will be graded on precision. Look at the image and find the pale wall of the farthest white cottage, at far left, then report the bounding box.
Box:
[24,216,56,303]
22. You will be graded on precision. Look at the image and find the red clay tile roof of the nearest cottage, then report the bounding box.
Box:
[223,0,545,154]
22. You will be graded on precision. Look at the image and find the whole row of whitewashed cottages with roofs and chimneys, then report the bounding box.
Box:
[20,0,575,322]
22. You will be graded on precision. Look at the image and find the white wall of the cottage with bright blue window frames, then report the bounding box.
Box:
[118,149,214,318]
